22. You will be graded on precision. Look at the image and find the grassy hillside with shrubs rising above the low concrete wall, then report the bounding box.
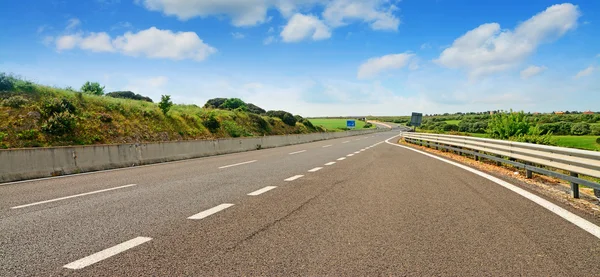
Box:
[0,74,321,148]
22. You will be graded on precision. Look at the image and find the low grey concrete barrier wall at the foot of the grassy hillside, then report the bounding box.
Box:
[0,129,384,183]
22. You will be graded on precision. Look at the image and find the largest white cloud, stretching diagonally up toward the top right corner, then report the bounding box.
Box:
[436,4,581,77]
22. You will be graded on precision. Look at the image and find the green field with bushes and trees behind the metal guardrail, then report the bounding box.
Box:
[369,111,600,151]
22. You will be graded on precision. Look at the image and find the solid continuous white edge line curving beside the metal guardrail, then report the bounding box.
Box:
[385,135,600,239]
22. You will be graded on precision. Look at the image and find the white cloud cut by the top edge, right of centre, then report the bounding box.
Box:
[323,0,400,31]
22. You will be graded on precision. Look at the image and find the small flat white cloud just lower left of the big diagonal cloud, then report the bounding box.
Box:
[358,52,418,79]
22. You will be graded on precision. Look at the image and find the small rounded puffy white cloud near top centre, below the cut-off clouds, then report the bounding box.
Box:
[280,13,331,42]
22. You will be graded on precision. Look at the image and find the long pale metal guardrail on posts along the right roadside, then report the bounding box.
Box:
[402,133,600,198]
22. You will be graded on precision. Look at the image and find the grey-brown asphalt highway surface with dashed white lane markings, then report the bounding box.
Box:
[0,128,600,276]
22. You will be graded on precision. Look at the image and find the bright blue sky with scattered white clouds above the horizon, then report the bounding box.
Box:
[0,0,600,116]
